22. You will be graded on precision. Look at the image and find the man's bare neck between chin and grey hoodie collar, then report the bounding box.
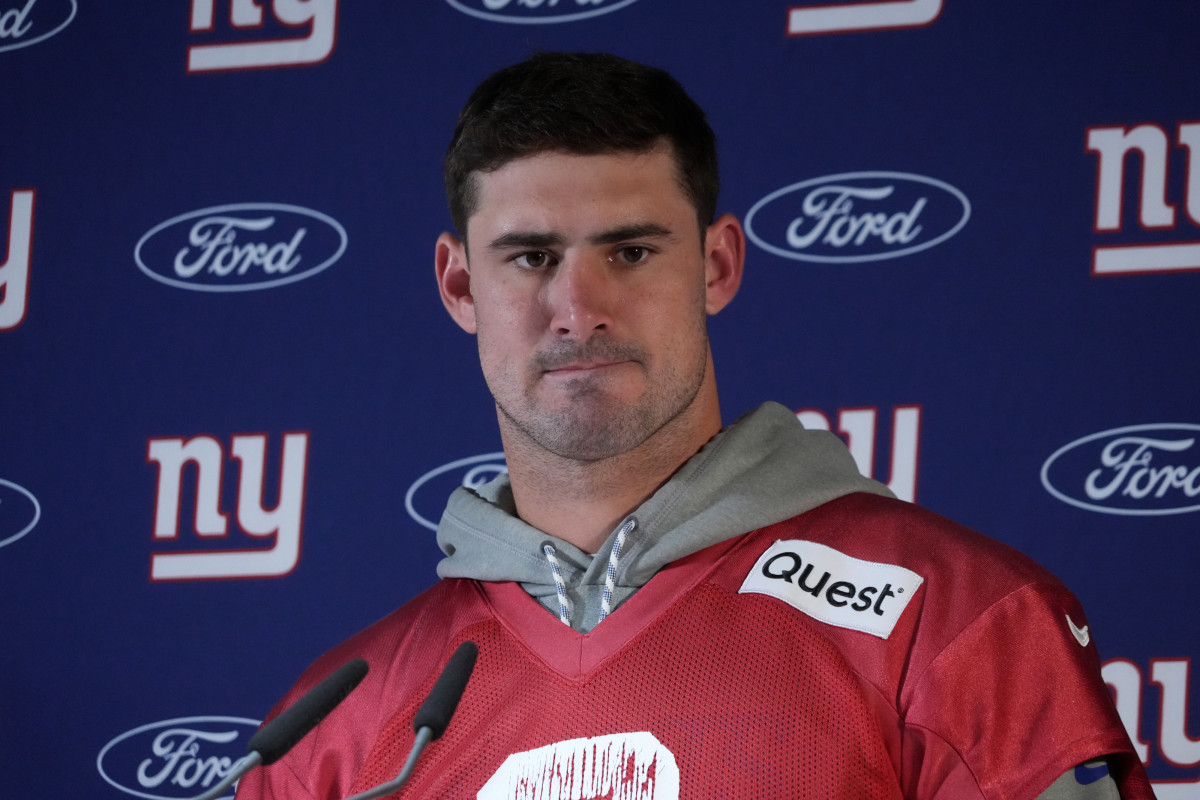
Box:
[500,386,721,553]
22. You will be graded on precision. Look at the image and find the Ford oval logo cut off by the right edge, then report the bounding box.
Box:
[1042,422,1200,516]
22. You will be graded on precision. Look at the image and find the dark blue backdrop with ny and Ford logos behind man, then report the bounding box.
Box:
[0,0,1200,800]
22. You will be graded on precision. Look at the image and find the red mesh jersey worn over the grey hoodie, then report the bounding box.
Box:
[239,495,1152,800]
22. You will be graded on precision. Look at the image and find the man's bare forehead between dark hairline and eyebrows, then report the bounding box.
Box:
[468,144,698,239]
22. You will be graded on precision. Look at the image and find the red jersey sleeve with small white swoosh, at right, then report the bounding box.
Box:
[901,583,1153,800]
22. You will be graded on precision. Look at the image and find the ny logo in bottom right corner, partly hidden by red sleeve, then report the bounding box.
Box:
[1100,658,1200,800]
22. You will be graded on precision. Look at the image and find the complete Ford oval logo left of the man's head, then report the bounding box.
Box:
[133,203,348,291]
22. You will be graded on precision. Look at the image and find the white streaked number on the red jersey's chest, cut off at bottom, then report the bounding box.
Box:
[475,730,679,800]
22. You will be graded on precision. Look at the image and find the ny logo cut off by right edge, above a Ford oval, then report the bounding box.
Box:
[1087,122,1200,276]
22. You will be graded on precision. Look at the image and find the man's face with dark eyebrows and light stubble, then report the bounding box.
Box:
[451,146,724,462]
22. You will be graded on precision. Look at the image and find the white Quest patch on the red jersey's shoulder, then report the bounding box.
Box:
[739,539,925,639]
